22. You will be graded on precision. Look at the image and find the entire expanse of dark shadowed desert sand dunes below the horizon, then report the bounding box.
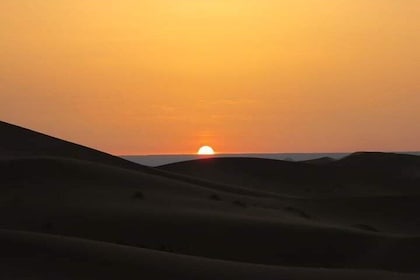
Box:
[0,119,420,280]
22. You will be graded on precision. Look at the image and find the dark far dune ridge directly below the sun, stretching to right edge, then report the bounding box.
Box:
[160,153,420,198]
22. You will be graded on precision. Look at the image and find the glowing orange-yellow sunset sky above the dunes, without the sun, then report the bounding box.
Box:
[0,0,420,155]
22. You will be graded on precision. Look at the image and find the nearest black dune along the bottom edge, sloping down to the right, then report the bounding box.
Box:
[0,230,418,280]
